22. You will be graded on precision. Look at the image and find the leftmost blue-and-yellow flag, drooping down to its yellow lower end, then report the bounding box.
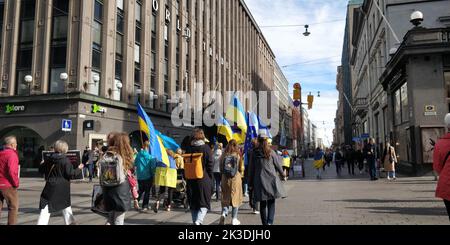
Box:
[138,103,177,188]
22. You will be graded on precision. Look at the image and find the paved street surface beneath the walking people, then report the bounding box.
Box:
[0,161,450,225]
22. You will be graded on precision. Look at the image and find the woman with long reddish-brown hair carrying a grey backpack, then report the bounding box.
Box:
[99,133,134,225]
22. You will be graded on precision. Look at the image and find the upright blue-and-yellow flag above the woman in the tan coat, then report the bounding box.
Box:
[225,95,247,144]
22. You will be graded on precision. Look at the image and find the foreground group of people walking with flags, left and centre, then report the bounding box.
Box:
[0,129,289,225]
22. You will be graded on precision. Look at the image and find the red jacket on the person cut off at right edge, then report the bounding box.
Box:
[433,133,450,201]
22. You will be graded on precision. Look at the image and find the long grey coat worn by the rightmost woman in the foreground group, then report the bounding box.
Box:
[248,149,287,202]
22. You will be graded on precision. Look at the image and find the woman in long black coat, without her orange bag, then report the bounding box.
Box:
[185,129,214,225]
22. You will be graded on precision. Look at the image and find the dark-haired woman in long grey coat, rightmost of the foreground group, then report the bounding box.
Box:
[248,133,286,225]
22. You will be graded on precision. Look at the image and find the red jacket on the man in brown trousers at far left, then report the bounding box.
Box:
[0,147,19,189]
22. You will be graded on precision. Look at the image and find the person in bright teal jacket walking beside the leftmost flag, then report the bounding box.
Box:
[134,141,156,212]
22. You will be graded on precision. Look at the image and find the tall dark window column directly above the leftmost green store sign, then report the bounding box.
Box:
[16,0,36,95]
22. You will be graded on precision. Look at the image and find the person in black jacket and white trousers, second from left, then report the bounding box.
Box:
[37,140,84,225]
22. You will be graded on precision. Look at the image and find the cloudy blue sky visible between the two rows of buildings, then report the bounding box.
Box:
[245,0,348,145]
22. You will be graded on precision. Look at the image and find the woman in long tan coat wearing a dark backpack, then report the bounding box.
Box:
[219,140,244,225]
